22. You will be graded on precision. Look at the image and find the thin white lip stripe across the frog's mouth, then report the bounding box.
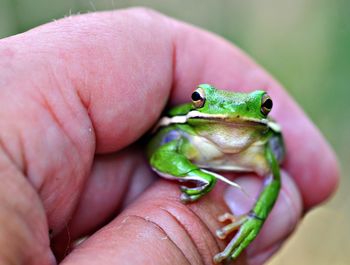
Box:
[155,110,280,131]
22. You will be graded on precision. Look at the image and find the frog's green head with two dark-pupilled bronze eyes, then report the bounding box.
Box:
[191,84,272,124]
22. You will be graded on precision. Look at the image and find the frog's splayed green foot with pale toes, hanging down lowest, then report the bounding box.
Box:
[214,213,264,263]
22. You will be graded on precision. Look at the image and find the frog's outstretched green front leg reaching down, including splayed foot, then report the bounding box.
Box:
[214,147,281,263]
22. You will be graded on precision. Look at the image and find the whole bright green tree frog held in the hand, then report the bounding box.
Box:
[148,84,284,263]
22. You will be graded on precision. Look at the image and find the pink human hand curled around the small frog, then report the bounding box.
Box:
[0,9,338,265]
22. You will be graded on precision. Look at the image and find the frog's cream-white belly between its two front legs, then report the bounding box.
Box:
[189,136,270,175]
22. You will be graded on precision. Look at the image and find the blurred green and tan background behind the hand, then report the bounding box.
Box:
[0,0,350,265]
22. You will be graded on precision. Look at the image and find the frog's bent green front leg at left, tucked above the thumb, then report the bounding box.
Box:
[150,138,216,203]
